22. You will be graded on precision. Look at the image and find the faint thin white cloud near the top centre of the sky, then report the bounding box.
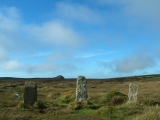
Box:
[57,3,102,23]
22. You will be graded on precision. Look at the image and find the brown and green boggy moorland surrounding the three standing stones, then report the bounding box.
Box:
[0,76,160,120]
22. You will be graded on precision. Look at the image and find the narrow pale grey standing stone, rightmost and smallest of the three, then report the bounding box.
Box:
[128,83,139,103]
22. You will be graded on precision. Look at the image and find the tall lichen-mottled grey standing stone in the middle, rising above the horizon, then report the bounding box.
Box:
[76,76,88,102]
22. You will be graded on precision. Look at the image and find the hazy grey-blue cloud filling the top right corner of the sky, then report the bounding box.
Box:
[96,0,160,28]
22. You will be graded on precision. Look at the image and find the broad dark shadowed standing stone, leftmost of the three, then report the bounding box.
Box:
[23,81,37,106]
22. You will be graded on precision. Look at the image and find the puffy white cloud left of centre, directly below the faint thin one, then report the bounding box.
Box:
[27,21,81,46]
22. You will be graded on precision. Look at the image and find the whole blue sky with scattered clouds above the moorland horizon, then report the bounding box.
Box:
[0,0,160,78]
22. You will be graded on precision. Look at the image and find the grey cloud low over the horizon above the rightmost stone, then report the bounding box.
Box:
[98,47,159,75]
